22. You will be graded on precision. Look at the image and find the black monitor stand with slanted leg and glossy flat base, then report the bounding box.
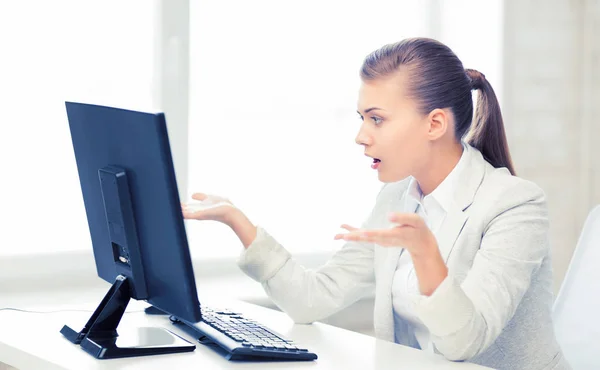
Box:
[60,275,196,359]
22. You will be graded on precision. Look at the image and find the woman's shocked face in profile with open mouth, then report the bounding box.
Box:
[356,73,429,182]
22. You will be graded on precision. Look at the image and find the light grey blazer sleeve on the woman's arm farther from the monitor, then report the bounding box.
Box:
[416,182,549,361]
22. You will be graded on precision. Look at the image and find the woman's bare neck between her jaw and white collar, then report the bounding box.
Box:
[414,142,463,195]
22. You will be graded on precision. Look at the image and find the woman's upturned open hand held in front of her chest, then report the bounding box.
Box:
[334,213,439,257]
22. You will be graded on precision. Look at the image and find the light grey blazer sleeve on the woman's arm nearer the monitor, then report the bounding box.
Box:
[238,185,390,324]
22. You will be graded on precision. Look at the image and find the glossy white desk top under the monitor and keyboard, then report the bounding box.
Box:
[0,300,484,370]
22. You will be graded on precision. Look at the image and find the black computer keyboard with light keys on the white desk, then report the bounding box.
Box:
[170,306,317,361]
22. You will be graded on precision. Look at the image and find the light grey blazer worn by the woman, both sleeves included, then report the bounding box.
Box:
[238,148,569,369]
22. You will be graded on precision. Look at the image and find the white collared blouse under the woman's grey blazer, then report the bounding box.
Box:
[392,144,469,352]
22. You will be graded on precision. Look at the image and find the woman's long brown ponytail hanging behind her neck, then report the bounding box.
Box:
[465,69,515,175]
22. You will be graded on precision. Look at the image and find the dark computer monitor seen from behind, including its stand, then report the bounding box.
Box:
[61,102,202,358]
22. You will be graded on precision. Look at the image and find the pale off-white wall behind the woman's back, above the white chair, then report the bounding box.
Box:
[502,0,600,290]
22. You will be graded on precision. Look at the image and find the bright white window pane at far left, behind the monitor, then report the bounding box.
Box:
[0,0,154,255]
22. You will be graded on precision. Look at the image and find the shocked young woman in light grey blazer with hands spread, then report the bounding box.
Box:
[183,38,569,370]
